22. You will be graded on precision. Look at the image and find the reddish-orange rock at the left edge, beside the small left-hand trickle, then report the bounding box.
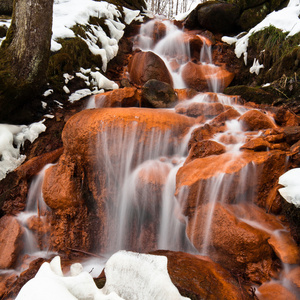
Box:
[0,216,24,269]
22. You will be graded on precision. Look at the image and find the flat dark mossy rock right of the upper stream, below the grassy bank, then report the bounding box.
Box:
[224,85,278,104]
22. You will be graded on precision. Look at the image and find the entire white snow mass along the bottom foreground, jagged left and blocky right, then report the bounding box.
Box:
[16,251,188,300]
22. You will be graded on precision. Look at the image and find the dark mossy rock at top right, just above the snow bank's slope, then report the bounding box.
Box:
[238,3,270,30]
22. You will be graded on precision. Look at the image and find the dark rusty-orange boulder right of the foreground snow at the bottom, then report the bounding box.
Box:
[151,250,250,300]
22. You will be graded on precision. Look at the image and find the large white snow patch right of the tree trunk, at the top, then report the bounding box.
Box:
[51,0,140,72]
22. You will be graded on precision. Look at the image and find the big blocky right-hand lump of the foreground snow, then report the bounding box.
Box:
[103,251,188,300]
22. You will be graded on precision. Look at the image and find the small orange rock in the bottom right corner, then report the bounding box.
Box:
[256,282,299,300]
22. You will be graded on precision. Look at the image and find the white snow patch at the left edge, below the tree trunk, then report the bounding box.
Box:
[0,121,46,180]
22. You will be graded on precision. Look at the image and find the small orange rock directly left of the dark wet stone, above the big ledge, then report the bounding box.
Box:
[95,87,141,108]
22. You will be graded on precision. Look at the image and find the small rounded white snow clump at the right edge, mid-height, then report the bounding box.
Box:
[278,168,300,208]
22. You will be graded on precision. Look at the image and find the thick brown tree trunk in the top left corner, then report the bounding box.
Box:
[0,0,54,122]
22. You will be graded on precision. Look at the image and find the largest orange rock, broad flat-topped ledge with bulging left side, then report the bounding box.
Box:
[43,108,193,253]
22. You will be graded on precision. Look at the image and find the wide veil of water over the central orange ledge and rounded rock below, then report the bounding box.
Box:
[99,122,190,253]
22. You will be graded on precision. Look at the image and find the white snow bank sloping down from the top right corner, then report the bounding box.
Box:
[222,0,300,65]
